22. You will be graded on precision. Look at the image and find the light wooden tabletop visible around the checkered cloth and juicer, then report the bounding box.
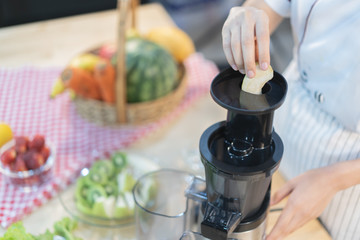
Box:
[0,4,331,240]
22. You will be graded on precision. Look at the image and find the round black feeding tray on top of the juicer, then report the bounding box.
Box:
[211,67,287,115]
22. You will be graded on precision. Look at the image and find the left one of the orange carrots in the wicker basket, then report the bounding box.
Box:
[61,67,101,100]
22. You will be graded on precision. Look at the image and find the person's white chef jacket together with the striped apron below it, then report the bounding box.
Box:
[265,0,360,240]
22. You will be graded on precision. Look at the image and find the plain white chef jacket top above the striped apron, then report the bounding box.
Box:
[266,0,360,133]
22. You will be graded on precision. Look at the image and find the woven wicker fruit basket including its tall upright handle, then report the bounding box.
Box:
[73,0,187,125]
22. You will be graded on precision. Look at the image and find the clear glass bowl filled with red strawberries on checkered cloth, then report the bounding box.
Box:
[0,135,55,191]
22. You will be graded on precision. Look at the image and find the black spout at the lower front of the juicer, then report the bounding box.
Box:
[201,203,242,240]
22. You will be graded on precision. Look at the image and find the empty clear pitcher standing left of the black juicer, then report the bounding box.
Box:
[133,169,206,240]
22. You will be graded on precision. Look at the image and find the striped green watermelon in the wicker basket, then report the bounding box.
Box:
[113,38,178,103]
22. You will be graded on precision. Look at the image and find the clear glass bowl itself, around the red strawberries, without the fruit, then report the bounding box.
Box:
[0,140,56,192]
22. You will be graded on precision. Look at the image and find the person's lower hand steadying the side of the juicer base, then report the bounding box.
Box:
[266,166,340,240]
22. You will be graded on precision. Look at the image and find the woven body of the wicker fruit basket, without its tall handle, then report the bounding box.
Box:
[73,66,187,125]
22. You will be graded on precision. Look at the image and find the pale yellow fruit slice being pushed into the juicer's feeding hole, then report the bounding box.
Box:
[241,64,274,95]
